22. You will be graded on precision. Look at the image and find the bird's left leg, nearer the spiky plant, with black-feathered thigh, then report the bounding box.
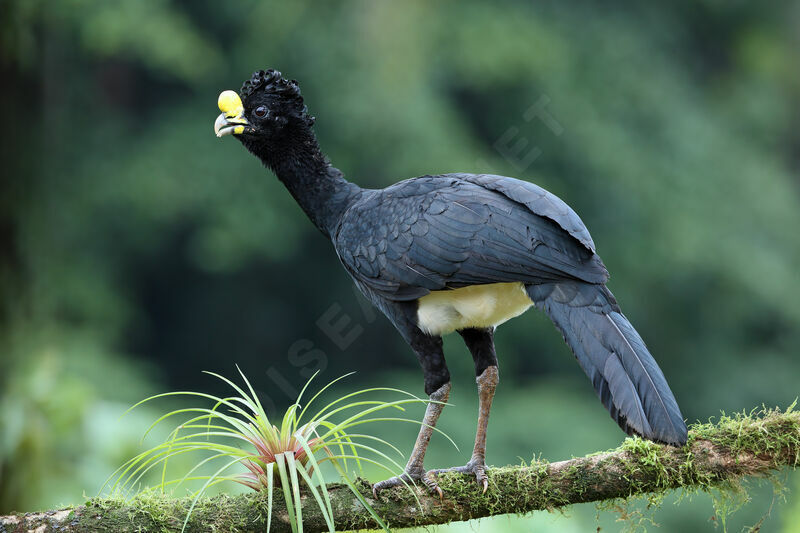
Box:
[372,333,450,497]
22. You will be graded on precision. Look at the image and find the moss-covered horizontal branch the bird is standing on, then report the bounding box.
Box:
[0,409,800,533]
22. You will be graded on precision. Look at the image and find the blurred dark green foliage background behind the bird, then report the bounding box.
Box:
[0,0,800,533]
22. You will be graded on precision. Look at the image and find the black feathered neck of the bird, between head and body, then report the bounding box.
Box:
[256,131,362,237]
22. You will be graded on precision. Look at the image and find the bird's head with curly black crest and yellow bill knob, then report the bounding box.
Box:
[214,69,314,155]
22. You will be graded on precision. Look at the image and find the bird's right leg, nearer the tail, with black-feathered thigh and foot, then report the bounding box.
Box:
[432,329,500,492]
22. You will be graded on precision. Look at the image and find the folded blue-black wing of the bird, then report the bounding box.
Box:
[334,174,608,301]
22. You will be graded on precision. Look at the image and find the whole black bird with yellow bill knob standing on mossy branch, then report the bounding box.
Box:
[214,69,686,494]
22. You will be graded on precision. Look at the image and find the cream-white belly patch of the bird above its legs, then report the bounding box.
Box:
[417,283,533,335]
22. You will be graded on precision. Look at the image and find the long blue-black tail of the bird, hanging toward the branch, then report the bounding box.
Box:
[527,281,686,445]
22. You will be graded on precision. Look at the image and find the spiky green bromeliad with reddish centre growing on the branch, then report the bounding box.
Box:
[104,367,455,533]
